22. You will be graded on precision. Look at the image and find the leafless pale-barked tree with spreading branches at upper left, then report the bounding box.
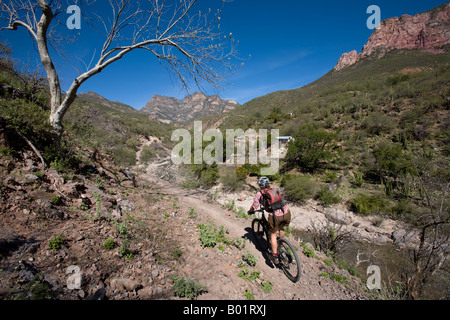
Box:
[0,0,237,144]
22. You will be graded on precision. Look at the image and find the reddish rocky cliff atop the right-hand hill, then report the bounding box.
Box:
[334,2,450,71]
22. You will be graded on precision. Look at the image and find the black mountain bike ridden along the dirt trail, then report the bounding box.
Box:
[252,208,302,283]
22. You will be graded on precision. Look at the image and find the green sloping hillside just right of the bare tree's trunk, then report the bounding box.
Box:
[64,92,174,167]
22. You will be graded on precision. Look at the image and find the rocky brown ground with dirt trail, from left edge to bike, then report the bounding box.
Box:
[0,139,386,300]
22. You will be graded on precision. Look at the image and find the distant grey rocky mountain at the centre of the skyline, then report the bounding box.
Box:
[141,92,240,123]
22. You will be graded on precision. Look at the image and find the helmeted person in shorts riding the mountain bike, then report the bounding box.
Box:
[248,177,291,263]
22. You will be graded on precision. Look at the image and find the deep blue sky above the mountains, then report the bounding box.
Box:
[0,0,447,110]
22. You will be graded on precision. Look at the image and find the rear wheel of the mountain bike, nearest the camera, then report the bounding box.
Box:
[278,238,302,283]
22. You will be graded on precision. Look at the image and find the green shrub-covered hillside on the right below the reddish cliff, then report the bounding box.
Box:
[216,50,450,221]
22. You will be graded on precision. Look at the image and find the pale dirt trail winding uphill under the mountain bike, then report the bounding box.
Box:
[139,168,370,300]
